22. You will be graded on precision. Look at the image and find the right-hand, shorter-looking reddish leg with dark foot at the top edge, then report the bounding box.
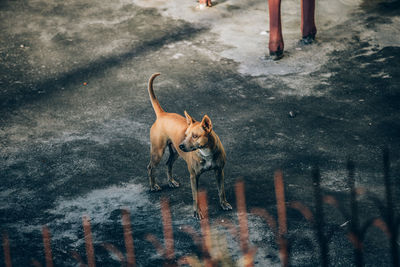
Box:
[301,0,317,39]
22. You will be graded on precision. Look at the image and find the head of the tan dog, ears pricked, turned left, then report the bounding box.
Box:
[179,110,212,152]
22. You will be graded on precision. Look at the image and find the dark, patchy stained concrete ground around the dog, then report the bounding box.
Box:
[0,0,400,266]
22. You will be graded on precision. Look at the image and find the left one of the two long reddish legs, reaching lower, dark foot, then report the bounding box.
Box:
[268,0,283,56]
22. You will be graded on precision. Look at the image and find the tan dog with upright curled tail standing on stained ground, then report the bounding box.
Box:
[147,73,232,219]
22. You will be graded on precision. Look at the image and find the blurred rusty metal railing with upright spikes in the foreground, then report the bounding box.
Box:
[2,150,400,267]
